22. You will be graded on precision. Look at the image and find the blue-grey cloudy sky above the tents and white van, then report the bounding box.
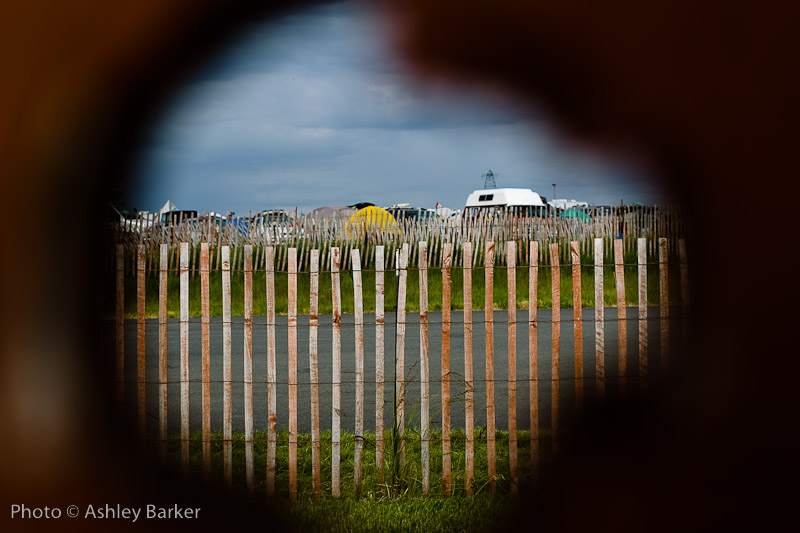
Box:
[127,2,659,213]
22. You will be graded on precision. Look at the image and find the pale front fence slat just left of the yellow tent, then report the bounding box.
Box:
[331,246,342,498]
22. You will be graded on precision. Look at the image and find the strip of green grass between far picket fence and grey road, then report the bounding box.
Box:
[104,243,681,318]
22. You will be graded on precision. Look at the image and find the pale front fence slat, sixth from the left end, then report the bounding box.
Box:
[220,246,233,489]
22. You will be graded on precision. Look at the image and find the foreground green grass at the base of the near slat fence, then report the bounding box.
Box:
[162,427,552,531]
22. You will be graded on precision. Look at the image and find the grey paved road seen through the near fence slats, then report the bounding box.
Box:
[107,307,680,432]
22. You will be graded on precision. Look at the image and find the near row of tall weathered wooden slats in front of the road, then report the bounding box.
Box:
[116,238,689,500]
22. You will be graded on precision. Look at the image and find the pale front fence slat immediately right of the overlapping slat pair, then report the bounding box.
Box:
[418,241,431,494]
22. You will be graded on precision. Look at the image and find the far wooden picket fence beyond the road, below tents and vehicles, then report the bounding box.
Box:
[111,205,689,273]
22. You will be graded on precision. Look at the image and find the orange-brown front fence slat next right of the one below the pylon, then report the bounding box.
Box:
[506,241,519,496]
